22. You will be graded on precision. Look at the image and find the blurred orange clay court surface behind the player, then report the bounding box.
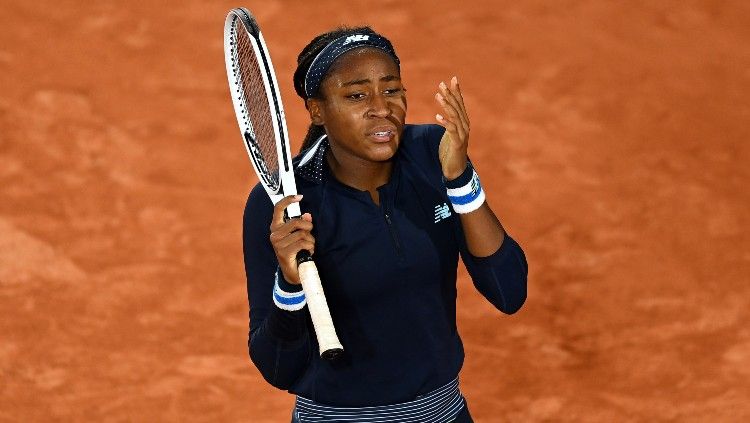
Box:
[0,0,750,422]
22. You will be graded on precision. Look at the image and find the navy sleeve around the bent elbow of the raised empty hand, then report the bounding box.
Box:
[459,232,529,314]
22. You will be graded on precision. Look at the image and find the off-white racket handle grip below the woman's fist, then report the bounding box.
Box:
[298,260,344,356]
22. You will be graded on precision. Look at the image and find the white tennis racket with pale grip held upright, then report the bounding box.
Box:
[224,8,344,359]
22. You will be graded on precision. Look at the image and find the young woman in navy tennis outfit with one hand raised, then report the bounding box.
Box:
[244,27,527,422]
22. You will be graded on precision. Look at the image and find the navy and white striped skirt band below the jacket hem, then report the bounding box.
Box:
[295,378,466,423]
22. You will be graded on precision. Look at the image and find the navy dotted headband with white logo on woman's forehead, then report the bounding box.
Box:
[305,33,401,98]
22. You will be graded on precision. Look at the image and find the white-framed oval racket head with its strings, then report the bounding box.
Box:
[224,8,298,205]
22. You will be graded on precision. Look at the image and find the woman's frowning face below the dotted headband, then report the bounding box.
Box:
[308,48,406,162]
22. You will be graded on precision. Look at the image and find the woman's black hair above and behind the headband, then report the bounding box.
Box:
[294,26,394,151]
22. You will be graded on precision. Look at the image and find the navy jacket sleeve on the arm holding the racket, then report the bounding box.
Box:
[242,184,312,390]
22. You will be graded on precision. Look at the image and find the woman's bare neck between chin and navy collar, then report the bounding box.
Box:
[326,146,393,204]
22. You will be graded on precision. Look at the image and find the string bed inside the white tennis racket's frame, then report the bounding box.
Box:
[232,19,279,189]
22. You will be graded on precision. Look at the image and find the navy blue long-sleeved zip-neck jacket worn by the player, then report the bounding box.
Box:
[243,125,527,406]
